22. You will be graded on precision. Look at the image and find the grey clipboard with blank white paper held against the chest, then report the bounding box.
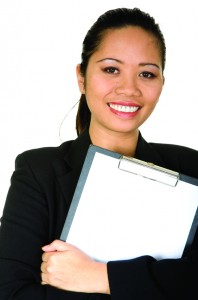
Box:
[60,145,198,262]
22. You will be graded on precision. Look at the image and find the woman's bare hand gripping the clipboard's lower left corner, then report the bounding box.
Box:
[41,240,110,294]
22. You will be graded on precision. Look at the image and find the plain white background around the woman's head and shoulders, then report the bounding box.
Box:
[0,0,198,214]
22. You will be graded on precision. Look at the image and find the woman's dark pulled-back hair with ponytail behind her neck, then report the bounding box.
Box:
[76,8,166,135]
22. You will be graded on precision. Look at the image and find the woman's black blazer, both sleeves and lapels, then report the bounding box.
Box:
[0,131,198,300]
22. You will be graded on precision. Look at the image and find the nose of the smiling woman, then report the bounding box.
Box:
[115,76,141,97]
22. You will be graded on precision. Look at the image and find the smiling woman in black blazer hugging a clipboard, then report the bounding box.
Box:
[0,9,198,300]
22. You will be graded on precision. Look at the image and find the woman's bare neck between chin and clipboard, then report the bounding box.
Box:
[89,127,139,156]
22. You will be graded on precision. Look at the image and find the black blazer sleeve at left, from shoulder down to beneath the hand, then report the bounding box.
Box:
[0,154,110,300]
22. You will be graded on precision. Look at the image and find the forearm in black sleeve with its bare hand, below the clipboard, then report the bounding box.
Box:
[41,237,198,300]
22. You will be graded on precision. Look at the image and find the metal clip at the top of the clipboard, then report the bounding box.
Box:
[118,155,179,187]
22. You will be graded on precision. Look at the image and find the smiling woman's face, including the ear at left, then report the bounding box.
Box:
[77,26,163,137]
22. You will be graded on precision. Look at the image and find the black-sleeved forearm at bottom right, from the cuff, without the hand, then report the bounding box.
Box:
[108,241,198,300]
